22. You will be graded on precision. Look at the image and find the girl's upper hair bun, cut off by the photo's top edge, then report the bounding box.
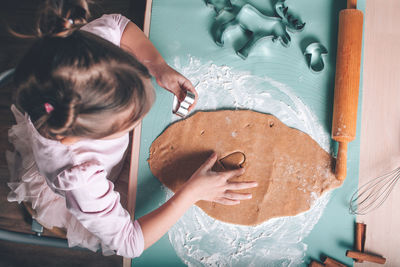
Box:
[36,0,90,37]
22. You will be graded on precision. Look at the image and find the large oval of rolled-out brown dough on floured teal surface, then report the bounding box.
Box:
[148,110,341,225]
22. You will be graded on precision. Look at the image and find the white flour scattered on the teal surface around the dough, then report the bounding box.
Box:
[166,57,330,266]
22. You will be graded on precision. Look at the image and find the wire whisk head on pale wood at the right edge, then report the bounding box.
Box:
[350,167,400,215]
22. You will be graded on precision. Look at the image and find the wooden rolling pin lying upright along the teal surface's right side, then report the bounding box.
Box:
[332,0,363,180]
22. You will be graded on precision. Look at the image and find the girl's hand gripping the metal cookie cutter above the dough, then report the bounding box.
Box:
[154,63,198,111]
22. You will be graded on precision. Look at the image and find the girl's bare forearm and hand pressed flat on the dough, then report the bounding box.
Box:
[138,153,257,249]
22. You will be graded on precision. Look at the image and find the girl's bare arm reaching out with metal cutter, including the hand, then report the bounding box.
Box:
[121,22,197,108]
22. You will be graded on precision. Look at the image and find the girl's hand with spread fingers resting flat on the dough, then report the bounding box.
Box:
[182,153,258,205]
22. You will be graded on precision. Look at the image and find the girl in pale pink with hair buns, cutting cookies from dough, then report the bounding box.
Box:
[7,0,256,257]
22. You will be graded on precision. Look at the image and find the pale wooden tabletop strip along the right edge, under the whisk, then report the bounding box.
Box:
[355,0,400,267]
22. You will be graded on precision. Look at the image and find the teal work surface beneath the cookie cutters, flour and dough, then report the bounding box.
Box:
[133,0,365,266]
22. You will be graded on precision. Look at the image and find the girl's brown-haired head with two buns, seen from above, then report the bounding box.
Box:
[15,0,154,139]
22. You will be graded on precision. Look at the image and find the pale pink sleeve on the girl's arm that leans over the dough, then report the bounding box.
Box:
[54,162,144,258]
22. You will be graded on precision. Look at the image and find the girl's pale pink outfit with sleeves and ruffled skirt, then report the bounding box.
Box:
[6,15,144,258]
